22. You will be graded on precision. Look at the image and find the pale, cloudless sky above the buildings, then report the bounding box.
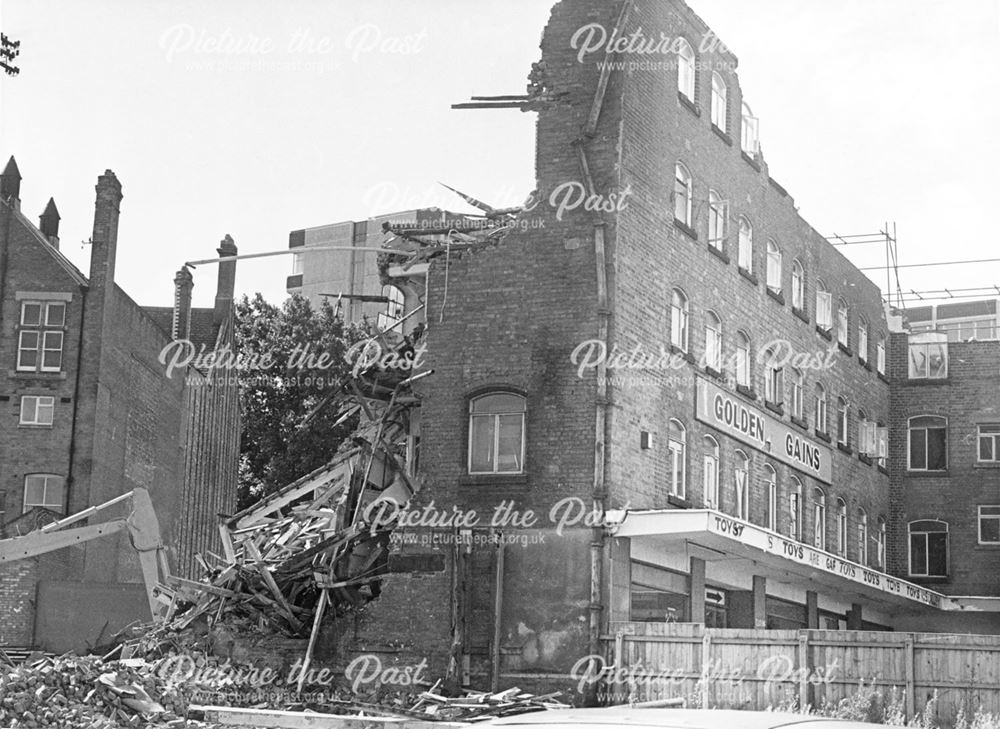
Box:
[0,0,1000,306]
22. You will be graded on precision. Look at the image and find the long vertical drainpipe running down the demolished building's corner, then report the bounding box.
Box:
[573,0,631,706]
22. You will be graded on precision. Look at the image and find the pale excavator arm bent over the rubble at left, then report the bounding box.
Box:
[0,488,171,621]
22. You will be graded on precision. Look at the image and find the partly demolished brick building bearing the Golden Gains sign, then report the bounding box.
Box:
[286,0,1000,687]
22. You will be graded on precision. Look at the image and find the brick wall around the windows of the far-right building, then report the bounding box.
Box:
[889,334,1000,595]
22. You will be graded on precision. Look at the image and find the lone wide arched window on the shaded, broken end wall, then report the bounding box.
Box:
[469,392,526,473]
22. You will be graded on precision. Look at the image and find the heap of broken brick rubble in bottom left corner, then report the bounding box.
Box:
[0,656,218,729]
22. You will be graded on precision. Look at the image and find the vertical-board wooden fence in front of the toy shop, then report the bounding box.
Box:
[599,623,1000,725]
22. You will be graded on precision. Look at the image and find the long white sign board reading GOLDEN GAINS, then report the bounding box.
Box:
[695,377,833,483]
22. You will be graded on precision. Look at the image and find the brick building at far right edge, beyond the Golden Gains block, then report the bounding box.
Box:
[889,318,1000,633]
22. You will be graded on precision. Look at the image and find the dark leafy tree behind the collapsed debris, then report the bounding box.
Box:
[236,293,363,509]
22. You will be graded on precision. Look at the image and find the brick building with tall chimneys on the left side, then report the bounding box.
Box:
[0,158,239,650]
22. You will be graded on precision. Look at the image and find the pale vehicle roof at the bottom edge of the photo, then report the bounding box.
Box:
[478,706,876,729]
